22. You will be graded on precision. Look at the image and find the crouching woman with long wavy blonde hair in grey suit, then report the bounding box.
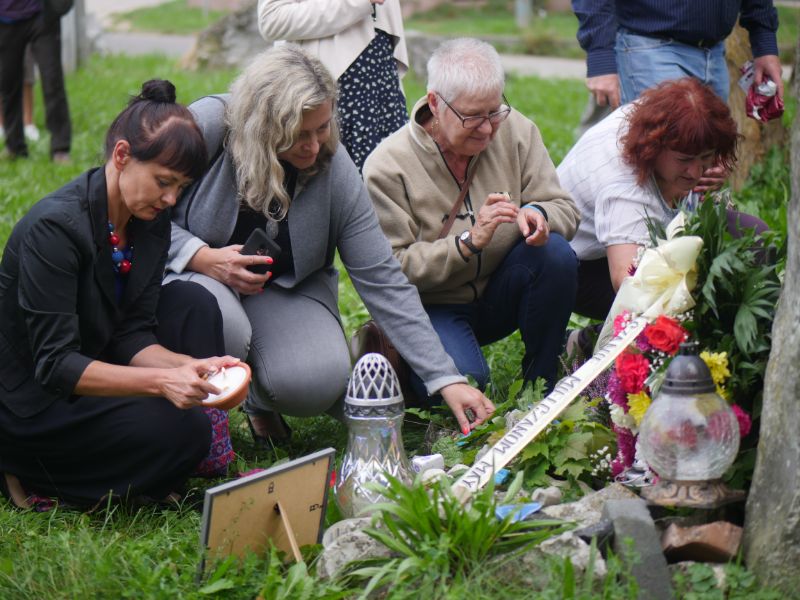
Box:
[166,44,494,442]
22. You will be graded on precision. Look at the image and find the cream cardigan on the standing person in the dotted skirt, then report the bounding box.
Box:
[258,0,408,79]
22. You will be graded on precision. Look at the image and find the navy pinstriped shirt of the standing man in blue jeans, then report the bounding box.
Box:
[572,0,778,77]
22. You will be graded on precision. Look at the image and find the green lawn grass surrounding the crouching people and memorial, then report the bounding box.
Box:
[0,49,794,599]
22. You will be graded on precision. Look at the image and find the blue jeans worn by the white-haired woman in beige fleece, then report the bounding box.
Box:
[411,233,578,398]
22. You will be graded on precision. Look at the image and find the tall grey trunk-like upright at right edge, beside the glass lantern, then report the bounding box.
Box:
[744,35,800,595]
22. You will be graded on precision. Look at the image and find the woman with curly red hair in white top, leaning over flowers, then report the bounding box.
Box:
[557,77,766,320]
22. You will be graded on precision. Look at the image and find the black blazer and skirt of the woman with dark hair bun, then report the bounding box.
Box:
[0,169,222,506]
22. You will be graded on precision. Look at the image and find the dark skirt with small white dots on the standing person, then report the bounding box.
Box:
[338,29,408,173]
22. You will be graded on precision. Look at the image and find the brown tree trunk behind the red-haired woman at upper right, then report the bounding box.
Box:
[725,25,786,190]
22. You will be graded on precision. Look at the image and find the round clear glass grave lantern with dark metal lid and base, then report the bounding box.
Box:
[639,342,744,508]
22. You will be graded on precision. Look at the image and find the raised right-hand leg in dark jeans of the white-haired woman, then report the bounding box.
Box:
[476,233,578,389]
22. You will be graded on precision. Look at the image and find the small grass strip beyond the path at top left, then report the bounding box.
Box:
[113,0,229,35]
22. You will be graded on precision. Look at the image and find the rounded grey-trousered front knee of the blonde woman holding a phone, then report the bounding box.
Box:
[242,286,351,417]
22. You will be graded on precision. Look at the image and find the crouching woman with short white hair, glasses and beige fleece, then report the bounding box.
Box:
[364,39,579,392]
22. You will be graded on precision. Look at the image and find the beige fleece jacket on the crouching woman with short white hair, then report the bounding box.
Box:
[364,98,580,304]
